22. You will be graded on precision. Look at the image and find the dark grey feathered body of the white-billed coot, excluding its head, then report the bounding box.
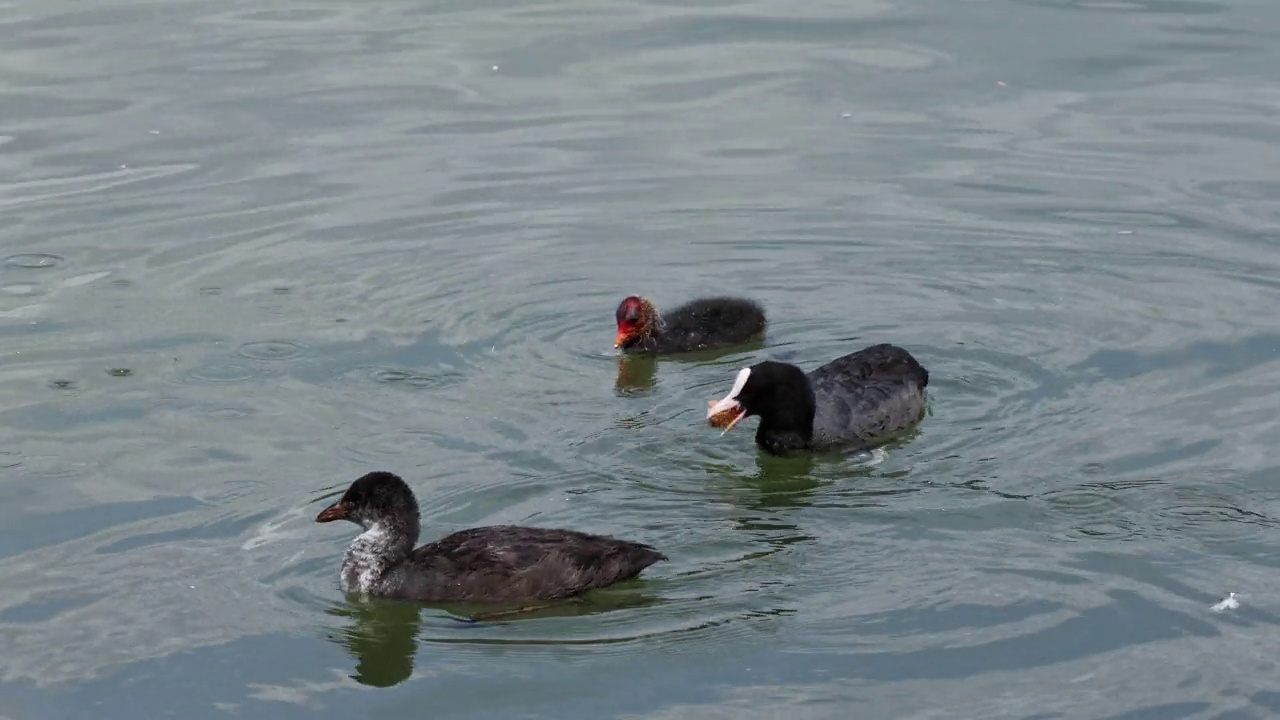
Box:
[809,345,929,447]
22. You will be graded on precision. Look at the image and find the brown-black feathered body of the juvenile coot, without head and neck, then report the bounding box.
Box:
[406,525,666,601]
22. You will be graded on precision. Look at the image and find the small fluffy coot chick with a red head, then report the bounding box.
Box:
[613,295,765,354]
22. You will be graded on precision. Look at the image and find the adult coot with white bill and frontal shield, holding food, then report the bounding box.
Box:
[707,345,929,455]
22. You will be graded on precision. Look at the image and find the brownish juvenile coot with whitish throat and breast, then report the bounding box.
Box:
[316,471,667,602]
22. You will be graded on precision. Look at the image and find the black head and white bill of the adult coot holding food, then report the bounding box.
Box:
[707,360,815,443]
